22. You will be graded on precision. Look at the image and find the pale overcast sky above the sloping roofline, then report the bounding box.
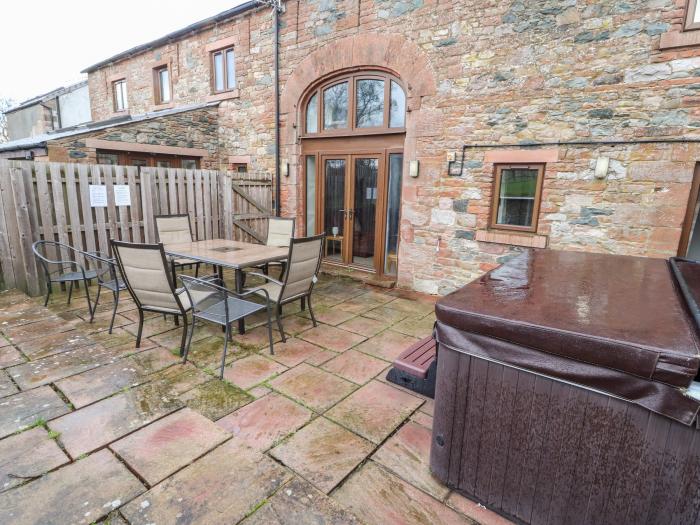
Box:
[0,0,252,102]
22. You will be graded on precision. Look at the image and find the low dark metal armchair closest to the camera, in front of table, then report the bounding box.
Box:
[180,275,275,378]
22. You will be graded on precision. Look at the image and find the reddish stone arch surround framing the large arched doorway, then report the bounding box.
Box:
[280,33,437,284]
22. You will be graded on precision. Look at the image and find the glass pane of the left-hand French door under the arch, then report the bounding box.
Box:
[323,159,346,261]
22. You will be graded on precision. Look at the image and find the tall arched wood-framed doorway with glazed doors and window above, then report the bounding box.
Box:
[300,69,406,276]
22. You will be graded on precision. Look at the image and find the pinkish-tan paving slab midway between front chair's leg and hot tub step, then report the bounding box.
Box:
[270,363,355,412]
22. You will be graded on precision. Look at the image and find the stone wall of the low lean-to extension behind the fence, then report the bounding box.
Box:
[48,106,219,169]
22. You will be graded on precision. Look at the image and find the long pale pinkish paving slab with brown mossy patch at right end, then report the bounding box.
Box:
[49,383,184,458]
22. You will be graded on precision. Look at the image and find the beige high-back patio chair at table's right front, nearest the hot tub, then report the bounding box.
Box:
[245,233,326,342]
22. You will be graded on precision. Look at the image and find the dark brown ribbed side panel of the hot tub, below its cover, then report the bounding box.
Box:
[431,346,700,525]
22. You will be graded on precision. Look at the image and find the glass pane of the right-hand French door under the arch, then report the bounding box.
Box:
[351,158,379,268]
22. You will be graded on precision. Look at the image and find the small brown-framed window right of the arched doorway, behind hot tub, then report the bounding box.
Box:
[491,164,544,232]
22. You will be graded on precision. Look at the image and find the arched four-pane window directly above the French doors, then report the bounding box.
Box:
[304,72,406,135]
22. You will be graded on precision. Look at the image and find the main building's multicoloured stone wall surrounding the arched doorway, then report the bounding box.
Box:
[85,0,700,293]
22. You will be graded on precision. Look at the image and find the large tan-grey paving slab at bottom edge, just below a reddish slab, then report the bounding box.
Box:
[122,441,291,525]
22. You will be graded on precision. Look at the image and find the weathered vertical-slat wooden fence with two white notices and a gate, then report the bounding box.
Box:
[0,160,272,295]
